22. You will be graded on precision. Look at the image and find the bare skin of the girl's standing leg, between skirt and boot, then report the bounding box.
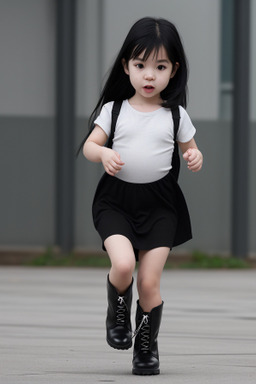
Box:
[137,247,170,312]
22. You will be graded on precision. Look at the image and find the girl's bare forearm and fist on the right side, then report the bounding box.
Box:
[179,139,203,172]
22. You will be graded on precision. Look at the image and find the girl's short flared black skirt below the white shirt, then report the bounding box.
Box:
[92,171,192,260]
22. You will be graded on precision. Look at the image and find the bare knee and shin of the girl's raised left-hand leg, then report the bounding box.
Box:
[104,235,136,294]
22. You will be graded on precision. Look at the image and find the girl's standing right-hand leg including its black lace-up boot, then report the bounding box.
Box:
[132,247,170,375]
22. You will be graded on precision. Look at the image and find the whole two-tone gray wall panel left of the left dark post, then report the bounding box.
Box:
[0,0,55,247]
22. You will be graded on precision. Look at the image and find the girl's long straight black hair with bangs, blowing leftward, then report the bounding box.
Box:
[78,17,188,153]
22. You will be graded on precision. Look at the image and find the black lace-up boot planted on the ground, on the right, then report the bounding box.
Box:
[132,301,163,375]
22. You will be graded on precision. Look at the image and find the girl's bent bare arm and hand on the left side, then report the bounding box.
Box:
[83,125,124,176]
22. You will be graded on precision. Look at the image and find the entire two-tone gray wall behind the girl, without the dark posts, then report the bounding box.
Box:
[0,0,256,254]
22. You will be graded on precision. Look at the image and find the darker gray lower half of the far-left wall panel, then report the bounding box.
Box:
[0,116,55,246]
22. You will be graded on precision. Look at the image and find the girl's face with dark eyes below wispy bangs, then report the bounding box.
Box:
[123,47,179,103]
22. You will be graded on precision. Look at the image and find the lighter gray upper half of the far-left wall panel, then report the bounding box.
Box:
[0,0,55,117]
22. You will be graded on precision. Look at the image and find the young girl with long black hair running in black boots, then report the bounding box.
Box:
[80,17,203,375]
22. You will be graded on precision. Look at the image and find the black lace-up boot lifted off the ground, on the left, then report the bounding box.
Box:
[106,276,133,349]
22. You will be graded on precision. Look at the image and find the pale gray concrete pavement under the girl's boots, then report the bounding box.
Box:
[0,267,256,384]
